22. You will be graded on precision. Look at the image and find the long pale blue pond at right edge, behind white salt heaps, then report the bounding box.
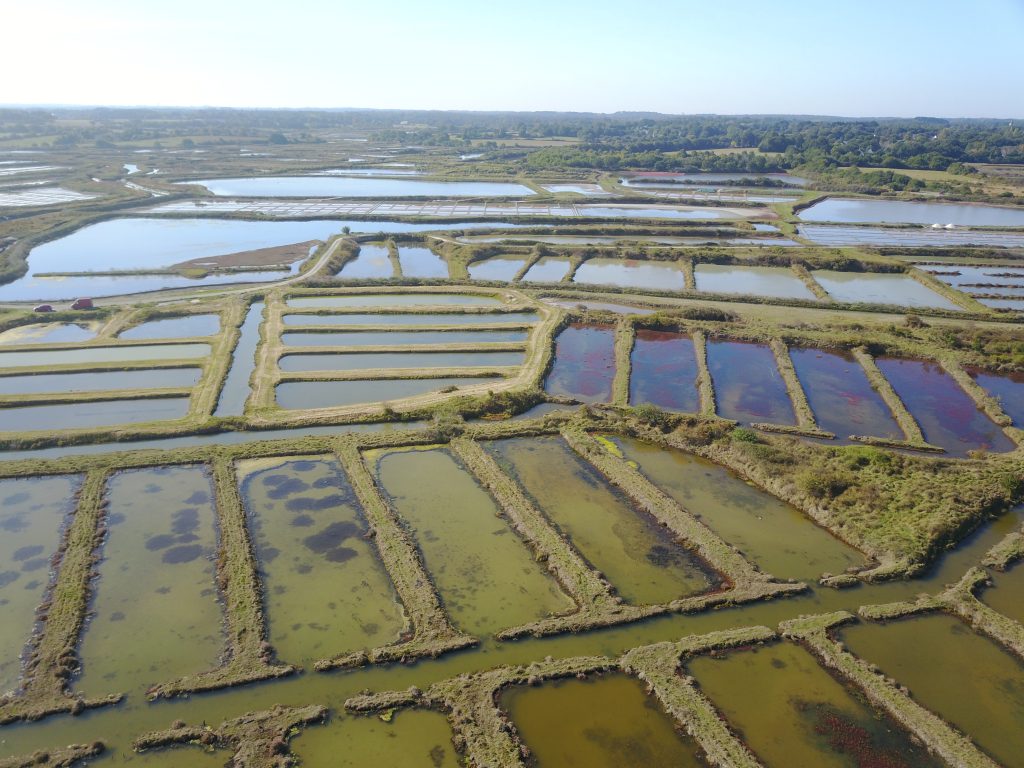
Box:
[799,198,1024,226]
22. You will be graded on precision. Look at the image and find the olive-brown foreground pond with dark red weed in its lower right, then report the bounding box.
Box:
[686,643,942,768]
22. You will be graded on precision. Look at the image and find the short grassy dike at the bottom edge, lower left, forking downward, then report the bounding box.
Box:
[133,705,328,768]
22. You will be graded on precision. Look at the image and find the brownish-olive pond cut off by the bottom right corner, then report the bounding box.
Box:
[839,613,1024,766]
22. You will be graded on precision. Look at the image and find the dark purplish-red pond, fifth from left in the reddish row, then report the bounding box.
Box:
[877,357,1014,457]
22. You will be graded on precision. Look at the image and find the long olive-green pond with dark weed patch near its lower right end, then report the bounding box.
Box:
[487,437,717,604]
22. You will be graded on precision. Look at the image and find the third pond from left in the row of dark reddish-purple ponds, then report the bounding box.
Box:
[708,340,796,424]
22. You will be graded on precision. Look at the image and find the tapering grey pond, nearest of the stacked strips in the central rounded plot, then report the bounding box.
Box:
[276,377,500,410]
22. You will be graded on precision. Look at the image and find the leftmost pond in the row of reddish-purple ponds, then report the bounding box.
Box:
[544,323,615,402]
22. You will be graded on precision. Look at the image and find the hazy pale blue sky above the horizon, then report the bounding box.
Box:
[8,0,1024,118]
